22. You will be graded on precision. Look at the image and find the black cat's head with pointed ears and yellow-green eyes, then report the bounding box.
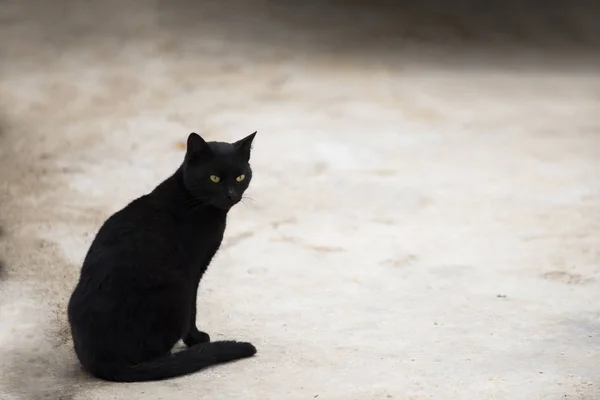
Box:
[183,132,256,210]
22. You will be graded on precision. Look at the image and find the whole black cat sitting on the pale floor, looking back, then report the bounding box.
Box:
[68,132,256,382]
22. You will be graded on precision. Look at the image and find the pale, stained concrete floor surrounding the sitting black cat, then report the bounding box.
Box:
[0,0,600,400]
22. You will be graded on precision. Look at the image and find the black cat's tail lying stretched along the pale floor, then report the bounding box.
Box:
[90,341,256,382]
